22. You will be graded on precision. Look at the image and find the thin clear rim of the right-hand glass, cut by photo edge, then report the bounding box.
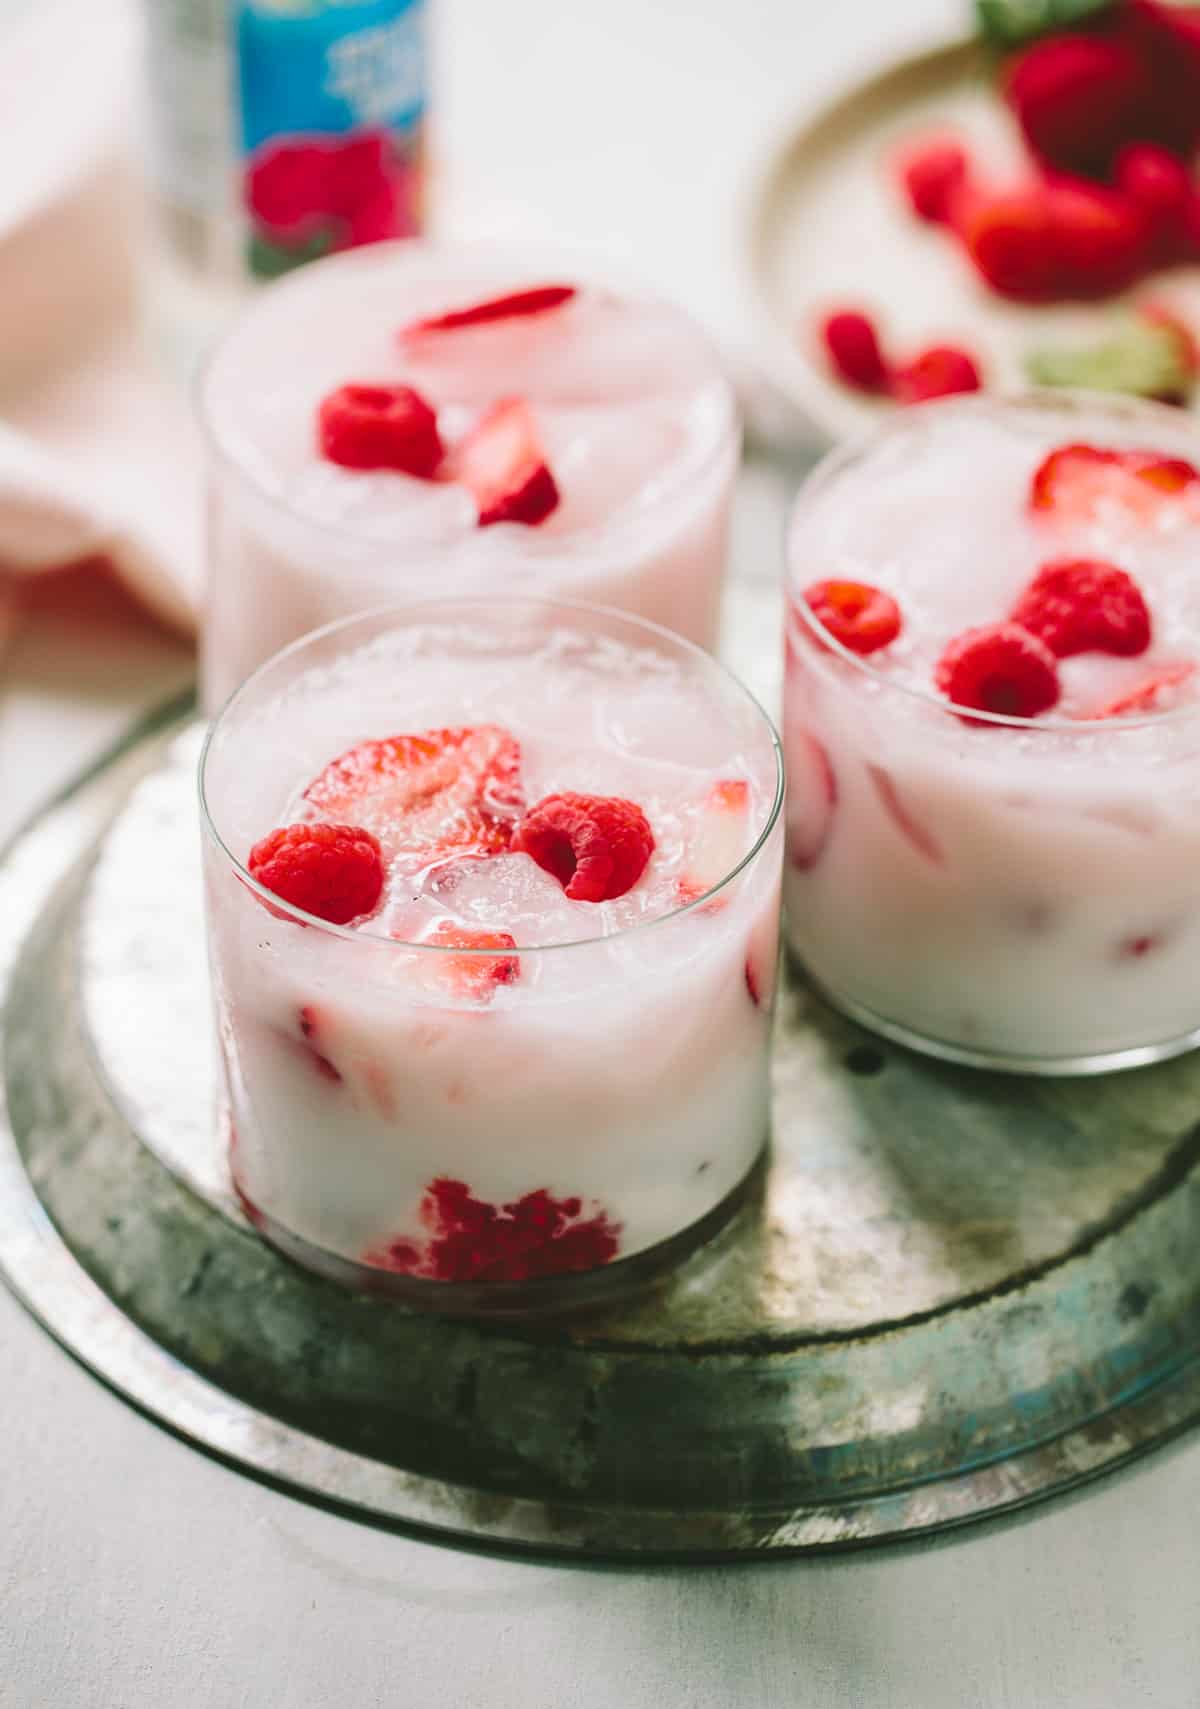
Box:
[783,386,1200,737]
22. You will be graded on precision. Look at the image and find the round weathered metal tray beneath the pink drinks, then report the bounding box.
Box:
[0,693,1200,1559]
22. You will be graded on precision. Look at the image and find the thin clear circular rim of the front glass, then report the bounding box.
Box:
[197,595,785,960]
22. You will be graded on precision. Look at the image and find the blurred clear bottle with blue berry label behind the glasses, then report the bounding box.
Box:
[147,0,426,280]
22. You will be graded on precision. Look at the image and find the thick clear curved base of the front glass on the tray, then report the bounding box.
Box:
[248,1143,768,1318]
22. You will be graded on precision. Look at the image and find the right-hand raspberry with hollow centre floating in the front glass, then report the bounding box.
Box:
[513,793,655,902]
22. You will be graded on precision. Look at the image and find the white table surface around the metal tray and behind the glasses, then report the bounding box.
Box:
[0,0,1200,1709]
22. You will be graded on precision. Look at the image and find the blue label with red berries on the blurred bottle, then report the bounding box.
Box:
[234,0,426,275]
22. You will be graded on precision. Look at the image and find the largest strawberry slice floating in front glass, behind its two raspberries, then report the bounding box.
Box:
[304,725,525,865]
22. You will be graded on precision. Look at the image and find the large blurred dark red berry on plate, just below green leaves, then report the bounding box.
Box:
[1003,34,1154,178]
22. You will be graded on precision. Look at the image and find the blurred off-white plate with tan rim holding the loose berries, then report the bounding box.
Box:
[745,38,1200,439]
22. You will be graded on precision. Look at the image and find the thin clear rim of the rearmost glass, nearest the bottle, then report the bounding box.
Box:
[191,238,742,564]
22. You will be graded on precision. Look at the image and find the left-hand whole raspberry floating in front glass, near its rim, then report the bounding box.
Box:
[250,825,383,926]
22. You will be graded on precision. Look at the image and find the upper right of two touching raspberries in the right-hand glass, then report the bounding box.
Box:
[1009,557,1150,658]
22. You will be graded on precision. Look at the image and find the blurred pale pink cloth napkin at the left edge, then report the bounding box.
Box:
[0,0,200,644]
